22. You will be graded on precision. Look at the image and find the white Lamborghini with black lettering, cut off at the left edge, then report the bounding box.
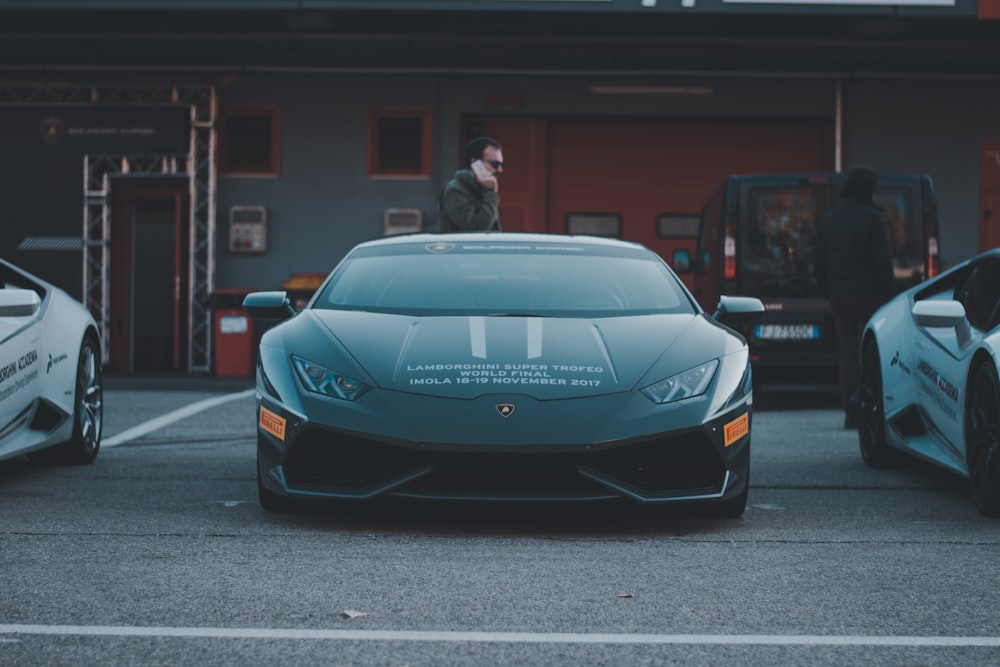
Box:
[0,260,103,464]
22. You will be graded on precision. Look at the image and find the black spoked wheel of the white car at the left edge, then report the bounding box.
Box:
[28,336,104,465]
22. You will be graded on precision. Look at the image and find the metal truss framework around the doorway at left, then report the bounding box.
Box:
[0,82,216,371]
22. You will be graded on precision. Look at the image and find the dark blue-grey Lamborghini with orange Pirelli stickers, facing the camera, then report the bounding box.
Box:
[244,233,763,516]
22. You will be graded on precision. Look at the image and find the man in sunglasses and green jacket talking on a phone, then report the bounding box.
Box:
[438,137,503,232]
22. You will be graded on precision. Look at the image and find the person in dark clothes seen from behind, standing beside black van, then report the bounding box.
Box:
[814,167,895,428]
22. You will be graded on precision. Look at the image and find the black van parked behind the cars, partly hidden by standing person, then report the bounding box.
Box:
[674,173,939,381]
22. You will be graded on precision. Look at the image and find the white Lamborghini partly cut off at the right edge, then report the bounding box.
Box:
[859,248,1000,516]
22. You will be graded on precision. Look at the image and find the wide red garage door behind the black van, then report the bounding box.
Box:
[547,119,833,270]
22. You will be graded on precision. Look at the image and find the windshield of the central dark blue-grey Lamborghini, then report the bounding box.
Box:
[313,242,695,317]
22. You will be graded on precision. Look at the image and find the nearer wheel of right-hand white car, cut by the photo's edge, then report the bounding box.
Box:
[965,362,1000,516]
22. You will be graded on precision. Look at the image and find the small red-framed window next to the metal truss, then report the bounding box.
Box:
[219,107,281,176]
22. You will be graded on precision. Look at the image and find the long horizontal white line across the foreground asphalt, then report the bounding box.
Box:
[0,624,1000,648]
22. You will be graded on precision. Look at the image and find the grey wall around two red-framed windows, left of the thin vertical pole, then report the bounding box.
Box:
[216,73,835,289]
